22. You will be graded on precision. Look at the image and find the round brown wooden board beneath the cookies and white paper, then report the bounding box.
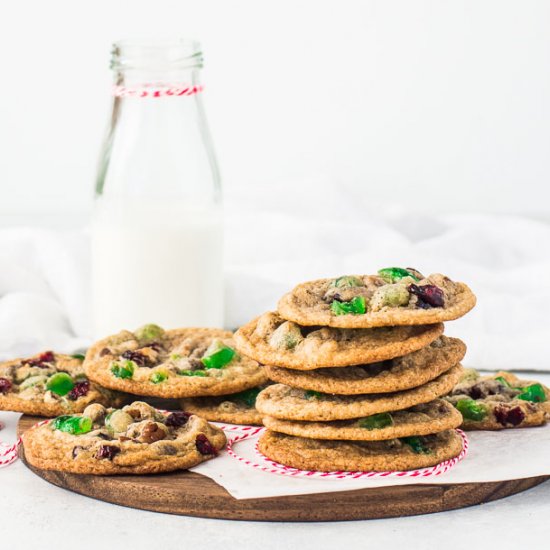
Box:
[18,416,550,521]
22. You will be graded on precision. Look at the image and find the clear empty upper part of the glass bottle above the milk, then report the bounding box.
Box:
[96,40,219,202]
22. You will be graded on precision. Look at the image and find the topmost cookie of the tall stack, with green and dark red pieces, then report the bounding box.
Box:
[277,267,476,328]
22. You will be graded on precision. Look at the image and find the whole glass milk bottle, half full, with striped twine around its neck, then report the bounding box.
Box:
[92,41,223,338]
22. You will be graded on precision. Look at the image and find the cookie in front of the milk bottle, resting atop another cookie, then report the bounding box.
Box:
[84,325,267,399]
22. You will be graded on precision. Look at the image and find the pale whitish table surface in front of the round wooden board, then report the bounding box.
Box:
[0,375,550,550]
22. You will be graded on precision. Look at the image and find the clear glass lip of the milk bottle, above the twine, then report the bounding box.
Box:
[111,38,203,71]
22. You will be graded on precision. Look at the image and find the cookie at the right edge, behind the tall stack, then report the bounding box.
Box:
[447,369,550,430]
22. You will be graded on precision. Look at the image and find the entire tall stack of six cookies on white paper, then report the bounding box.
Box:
[235,268,475,471]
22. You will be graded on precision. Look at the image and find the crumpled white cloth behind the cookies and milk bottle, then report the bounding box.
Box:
[0,198,550,370]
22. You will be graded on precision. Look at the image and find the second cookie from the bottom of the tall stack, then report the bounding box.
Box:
[263,399,462,441]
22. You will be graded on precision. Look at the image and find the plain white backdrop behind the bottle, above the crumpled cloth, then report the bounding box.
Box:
[0,0,550,224]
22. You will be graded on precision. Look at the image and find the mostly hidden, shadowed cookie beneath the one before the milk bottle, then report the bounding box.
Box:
[181,386,270,426]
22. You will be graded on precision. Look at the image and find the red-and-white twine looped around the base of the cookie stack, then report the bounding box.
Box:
[227,428,468,479]
